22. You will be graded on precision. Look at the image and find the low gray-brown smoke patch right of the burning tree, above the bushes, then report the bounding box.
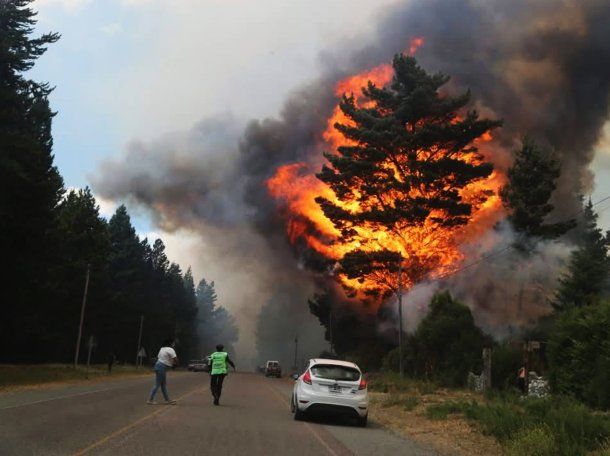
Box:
[388,222,574,339]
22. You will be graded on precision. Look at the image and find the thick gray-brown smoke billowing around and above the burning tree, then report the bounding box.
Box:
[94,0,610,356]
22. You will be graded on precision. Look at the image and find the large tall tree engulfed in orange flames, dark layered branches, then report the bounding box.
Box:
[316,55,501,297]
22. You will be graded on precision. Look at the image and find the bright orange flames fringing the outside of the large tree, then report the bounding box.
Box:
[267,50,505,298]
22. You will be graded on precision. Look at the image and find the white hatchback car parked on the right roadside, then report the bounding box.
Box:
[290,359,369,427]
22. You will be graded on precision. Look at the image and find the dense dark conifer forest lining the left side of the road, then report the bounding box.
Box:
[0,0,237,363]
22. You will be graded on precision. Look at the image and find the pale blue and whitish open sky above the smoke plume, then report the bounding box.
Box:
[33,0,395,232]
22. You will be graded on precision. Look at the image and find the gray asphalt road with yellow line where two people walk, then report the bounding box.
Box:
[0,372,434,456]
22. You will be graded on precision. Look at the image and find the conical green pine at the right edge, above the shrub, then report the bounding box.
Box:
[552,200,610,310]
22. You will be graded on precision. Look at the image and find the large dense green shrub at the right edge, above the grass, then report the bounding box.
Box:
[548,301,610,409]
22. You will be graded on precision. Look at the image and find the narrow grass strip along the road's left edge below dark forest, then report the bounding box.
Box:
[0,364,149,391]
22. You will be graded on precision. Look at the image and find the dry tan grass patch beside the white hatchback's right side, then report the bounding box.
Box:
[370,383,503,456]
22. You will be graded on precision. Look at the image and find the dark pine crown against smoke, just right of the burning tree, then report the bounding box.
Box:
[500,138,575,239]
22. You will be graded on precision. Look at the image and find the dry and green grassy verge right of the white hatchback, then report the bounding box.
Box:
[369,374,610,456]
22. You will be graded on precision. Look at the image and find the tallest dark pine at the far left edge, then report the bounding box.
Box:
[0,0,63,360]
